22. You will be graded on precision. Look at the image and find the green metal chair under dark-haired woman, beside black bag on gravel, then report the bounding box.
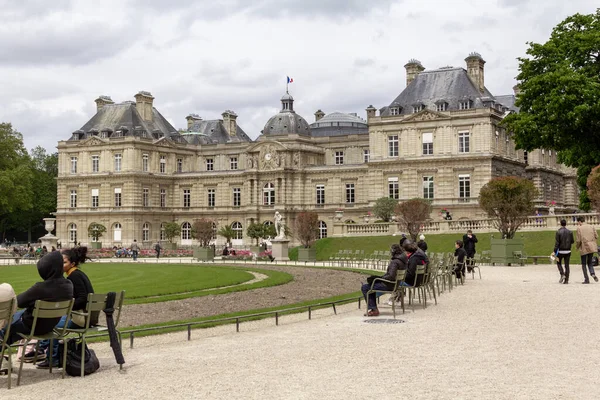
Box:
[67,290,125,377]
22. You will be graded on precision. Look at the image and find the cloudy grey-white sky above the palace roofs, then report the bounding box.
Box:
[0,0,596,151]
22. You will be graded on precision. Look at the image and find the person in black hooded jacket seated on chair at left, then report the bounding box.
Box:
[0,251,73,344]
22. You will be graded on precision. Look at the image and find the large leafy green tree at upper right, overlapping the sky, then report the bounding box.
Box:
[504,9,600,210]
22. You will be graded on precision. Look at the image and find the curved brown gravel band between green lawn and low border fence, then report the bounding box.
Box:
[119,265,366,327]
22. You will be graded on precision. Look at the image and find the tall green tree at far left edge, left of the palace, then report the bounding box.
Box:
[0,123,33,240]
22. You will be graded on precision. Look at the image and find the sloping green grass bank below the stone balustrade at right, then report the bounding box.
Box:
[290,231,600,261]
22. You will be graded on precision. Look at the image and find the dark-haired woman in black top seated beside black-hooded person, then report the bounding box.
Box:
[31,247,99,368]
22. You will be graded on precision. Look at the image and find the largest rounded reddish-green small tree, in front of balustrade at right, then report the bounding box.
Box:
[479,176,538,239]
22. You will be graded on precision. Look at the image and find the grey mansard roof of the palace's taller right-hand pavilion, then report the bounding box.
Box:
[380,67,497,116]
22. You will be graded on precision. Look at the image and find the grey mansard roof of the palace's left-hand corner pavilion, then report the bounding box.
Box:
[69,101,182,142]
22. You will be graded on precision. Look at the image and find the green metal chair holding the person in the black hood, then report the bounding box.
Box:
[17,299,74,386]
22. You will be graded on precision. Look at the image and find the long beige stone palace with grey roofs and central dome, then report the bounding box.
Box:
[56,53,578,247]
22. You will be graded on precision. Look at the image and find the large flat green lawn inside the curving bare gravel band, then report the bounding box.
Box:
[0,263,293,304]
